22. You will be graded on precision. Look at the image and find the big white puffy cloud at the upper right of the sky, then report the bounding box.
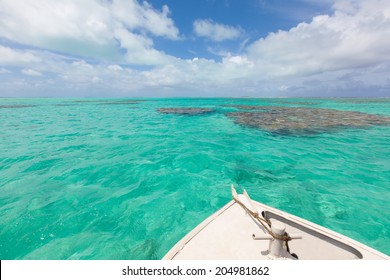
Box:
[247,0,390,76]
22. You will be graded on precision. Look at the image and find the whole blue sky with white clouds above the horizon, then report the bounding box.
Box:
[0,0,390,97]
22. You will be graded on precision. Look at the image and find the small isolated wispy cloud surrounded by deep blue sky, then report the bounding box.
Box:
[193,19,243,42]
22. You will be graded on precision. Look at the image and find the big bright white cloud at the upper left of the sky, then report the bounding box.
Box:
[0,0,179,64]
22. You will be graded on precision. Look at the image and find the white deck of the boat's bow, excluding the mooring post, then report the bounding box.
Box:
[164,195,389,260]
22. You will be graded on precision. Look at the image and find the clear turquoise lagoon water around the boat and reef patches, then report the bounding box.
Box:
[0,99,390,259]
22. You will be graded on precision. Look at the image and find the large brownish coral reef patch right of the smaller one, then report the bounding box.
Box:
[227,105,390,134]
